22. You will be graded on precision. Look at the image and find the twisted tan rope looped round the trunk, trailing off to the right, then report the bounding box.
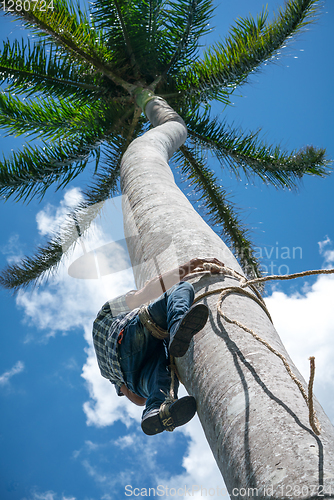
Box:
[180,262,334,435]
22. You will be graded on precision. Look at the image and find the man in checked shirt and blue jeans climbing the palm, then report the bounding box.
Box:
[93,259,222,435]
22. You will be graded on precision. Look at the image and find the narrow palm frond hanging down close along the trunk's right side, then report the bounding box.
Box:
[176,145,261,277]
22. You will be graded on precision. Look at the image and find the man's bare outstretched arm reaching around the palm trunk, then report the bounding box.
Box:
[125,258,224,309]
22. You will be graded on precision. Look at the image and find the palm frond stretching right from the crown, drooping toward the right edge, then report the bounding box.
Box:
[184,112,330,189]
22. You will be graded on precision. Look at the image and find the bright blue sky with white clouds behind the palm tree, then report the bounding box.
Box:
[0,0,334,500]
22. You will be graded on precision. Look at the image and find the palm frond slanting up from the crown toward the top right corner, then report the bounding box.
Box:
[176,0,319,103]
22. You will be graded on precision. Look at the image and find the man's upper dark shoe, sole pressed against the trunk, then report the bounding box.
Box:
[169,304,209,358]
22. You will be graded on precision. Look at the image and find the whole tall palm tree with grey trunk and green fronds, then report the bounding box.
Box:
[0,0,334,498]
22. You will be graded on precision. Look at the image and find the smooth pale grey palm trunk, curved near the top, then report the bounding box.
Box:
[121,98,334,499]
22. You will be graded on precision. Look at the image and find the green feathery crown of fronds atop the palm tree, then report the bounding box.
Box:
[0,0,328,290]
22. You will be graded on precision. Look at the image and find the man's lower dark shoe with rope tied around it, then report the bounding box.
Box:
[141,396,196,436]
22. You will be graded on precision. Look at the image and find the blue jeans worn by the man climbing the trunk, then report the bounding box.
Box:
[118,281,195,416]
